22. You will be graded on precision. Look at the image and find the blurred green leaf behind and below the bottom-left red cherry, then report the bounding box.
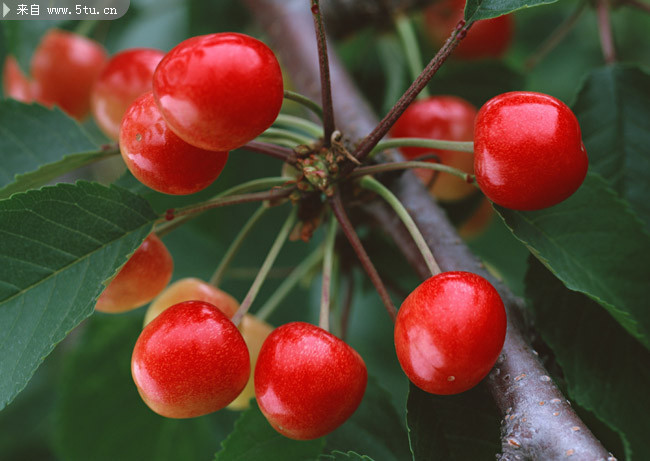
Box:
[54,313,235,461]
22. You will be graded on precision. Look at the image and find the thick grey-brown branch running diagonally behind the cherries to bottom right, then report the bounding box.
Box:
[246,0,610,460]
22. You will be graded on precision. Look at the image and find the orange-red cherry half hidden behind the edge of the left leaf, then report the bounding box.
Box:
[95,234,174,313]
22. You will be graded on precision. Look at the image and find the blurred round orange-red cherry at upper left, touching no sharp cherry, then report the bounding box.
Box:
[31,29,108,119]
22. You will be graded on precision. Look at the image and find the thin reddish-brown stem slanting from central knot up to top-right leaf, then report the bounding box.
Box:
[352,20,471,161]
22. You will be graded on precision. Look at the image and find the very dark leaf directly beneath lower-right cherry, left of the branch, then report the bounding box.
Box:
[406,384,501,461]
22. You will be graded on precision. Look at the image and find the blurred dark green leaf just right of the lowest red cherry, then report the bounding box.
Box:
[327,376,410,461]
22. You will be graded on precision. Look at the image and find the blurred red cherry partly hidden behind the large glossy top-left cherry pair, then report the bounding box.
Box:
[90,48,165,140]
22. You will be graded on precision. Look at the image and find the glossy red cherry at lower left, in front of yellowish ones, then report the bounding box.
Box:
[131,301,250,418]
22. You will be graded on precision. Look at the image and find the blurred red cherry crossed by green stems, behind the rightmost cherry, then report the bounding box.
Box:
[390,96,477,201]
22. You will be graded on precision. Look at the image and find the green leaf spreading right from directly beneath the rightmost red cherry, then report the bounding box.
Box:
[497,173,650,347]
